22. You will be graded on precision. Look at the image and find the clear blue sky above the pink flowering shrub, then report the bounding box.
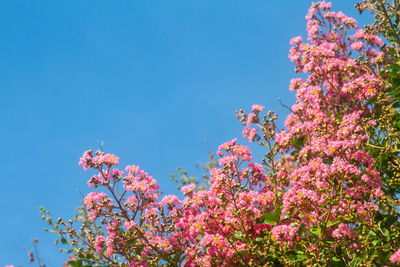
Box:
[0,0,365,266]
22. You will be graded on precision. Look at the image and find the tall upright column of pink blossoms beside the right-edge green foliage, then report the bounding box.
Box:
[243,2,384,260]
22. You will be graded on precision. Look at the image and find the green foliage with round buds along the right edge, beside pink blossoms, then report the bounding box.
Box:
[352,0,400,266]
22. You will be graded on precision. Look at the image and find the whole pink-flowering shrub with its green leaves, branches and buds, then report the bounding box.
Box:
[41,2,400,266]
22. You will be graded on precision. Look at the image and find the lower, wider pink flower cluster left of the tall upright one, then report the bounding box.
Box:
[76,139,278,266]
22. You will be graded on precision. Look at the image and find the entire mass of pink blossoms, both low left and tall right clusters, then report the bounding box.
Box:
[71,2,388,266]
